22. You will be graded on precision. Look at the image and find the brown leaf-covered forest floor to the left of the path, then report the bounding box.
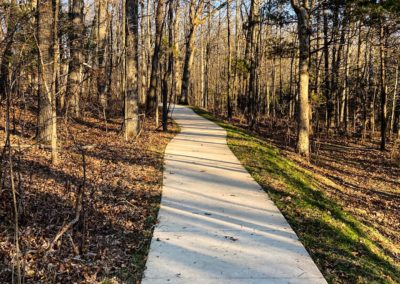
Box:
[0,105,178,283]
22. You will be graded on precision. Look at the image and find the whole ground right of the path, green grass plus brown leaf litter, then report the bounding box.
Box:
[195,109,400,283]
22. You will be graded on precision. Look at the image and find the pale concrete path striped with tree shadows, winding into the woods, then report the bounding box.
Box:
[142,106,326,284]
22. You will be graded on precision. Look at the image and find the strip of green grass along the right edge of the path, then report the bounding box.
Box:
[194,108,400,283]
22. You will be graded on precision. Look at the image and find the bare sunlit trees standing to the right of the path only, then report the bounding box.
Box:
[181,0,400,156]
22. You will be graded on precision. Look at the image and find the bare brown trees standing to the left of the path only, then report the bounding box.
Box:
[0,0,169,163]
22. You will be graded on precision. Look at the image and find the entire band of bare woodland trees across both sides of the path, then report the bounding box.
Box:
[0,0,400,161]
